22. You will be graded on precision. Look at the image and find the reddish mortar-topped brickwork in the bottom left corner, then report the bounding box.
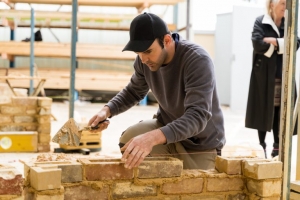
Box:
[0,164,24,200]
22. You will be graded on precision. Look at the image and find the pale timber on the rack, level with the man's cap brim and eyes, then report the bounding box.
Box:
[0,41,136,60]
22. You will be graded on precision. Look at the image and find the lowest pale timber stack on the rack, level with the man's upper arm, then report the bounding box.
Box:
[0,68,131,92]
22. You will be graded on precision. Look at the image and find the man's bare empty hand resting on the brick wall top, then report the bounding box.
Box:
[121,129,167,169]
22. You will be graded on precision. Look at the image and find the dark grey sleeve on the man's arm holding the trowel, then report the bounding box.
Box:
[106,56,149,117]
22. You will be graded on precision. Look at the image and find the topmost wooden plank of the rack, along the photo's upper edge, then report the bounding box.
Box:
[1,0,184,8]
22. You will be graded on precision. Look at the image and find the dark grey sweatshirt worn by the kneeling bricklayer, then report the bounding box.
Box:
[107,34,226,151]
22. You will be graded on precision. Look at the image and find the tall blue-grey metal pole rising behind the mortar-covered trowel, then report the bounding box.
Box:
[69,0,77,118]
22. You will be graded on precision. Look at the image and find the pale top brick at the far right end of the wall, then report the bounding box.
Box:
[243,160,282,180]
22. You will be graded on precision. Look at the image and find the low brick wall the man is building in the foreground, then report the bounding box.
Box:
[17,157,282,200]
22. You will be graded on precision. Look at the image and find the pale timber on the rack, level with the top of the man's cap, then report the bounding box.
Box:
[0,10,176,31]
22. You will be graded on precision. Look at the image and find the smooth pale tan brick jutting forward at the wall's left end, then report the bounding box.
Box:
[30,167,61,191]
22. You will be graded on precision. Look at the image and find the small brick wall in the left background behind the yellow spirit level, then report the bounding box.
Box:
[0,97,52,152]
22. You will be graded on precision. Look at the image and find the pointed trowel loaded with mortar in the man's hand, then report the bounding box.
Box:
[52,118,108,146]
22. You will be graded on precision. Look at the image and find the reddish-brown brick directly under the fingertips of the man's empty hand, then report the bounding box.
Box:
[79,159,133,181]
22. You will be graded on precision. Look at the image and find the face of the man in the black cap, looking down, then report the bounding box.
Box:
[135,39,167,71]
